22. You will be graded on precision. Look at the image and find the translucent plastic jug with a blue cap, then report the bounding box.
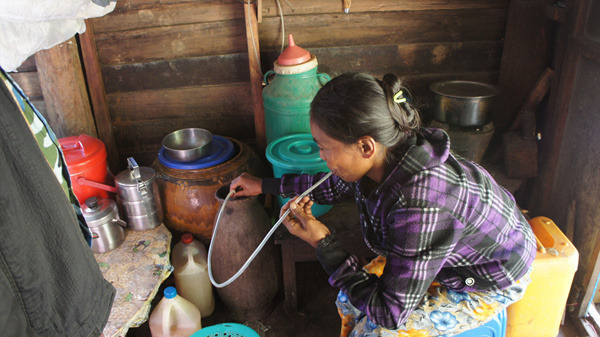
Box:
[149,287,202,337]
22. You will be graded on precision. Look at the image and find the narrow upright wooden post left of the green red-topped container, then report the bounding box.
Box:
[244,3,267,152]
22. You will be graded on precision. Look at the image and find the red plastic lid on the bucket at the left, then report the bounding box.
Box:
[58,135,106,168]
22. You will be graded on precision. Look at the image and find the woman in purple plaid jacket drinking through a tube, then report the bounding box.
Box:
[231,73,535,336]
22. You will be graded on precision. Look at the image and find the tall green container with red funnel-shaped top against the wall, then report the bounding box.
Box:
[262,34,331,144]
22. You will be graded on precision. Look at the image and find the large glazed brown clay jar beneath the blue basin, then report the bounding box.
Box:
[152,138,266,245]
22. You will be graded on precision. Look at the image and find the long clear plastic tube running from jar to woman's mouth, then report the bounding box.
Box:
[208,172,333,288]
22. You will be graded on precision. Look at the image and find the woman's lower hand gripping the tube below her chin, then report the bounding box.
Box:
[279,196,331,247]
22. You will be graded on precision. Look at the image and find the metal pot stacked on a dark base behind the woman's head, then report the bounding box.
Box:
[429,81,500,163]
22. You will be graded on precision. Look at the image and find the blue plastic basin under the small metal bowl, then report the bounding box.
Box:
[158,135,235,170]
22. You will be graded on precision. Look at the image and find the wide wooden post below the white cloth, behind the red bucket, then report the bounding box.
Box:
[35,37,98,138]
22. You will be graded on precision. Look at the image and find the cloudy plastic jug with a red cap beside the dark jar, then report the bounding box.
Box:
[171,233,215,317]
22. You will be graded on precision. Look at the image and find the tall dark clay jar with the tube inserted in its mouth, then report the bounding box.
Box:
[211,185,279,322]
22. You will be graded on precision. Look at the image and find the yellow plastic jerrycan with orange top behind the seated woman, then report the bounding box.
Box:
[506,216,579,337]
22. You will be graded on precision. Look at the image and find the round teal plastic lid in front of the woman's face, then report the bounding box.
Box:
[266,133,327,170]
